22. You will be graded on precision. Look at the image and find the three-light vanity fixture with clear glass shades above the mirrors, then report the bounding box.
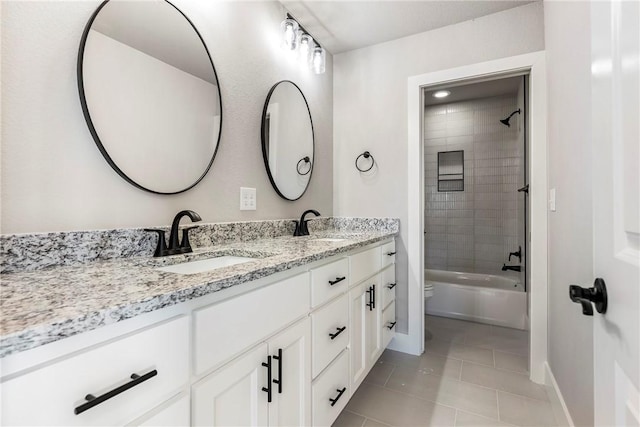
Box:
[280,13,326,74]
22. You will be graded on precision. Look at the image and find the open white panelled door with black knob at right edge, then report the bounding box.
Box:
[592,1,640,426]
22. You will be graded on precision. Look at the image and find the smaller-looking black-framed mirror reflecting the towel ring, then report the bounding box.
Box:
[262,80,314,200]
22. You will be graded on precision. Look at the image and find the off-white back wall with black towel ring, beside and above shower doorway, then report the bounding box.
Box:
[333,3,544,332]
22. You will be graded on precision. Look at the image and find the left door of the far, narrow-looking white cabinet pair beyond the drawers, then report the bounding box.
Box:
[349,282,370,390]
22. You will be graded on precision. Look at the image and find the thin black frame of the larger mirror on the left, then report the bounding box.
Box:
[76,0,223,195]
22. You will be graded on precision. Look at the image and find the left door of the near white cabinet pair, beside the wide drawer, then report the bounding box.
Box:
[191,344,268,426]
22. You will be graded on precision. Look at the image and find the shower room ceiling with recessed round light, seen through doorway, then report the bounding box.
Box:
[424,76,522,106]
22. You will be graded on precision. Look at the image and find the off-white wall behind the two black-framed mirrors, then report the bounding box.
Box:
[1,0,333,233]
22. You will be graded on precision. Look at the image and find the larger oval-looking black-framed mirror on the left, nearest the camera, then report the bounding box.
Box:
[78,0,222,194]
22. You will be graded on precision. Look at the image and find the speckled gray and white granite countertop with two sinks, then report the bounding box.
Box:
[0,231,396,357]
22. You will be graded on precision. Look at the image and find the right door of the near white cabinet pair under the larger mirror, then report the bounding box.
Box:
[267,317,311,426]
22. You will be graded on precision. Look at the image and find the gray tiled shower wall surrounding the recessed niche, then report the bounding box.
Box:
[424,96,524,275]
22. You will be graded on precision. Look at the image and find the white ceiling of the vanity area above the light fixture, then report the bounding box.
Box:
[280,0,532,54]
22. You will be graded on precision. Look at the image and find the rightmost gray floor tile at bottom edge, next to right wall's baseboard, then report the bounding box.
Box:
[498,391,556,427]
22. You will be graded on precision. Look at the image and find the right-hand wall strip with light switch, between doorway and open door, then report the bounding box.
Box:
[545,1,594,426]
